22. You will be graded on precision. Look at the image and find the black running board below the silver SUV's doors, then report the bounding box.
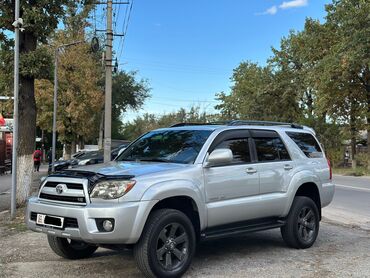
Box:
[201,219,285,240]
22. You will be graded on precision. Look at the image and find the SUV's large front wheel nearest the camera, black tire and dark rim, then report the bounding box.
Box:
[134,209,196,277]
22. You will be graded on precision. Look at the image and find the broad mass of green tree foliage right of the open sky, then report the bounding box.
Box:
[216,0,370,167]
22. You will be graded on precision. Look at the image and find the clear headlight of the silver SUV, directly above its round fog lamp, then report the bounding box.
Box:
[90,180,136,199]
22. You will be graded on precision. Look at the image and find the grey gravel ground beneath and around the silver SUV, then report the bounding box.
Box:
[0,220,370,278]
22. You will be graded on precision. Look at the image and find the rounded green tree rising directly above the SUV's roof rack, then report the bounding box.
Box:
[216,62,298,121]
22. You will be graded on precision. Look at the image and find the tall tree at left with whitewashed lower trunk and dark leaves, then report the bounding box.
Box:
[0,0,92,204]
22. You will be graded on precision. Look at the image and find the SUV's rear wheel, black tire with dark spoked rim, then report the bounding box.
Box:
[280,196,320,249]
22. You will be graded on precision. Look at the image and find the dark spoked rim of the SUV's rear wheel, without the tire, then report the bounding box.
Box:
[298,207,316,242]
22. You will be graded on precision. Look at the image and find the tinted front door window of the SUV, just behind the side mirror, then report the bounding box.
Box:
[215,138,251,164]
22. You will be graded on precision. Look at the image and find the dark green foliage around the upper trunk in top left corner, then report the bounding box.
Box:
[0,0,81,78]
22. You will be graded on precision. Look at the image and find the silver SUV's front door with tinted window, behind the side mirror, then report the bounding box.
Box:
[204,130,259,227]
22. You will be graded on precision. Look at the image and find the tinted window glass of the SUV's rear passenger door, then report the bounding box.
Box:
[254,137,290,161]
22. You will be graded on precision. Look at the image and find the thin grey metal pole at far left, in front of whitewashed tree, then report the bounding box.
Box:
[10,0,23,219]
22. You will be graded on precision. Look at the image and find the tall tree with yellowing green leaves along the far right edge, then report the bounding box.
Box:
[325,0,370,169]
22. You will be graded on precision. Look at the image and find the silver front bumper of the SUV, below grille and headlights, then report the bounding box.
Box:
[25,197,156,244]
